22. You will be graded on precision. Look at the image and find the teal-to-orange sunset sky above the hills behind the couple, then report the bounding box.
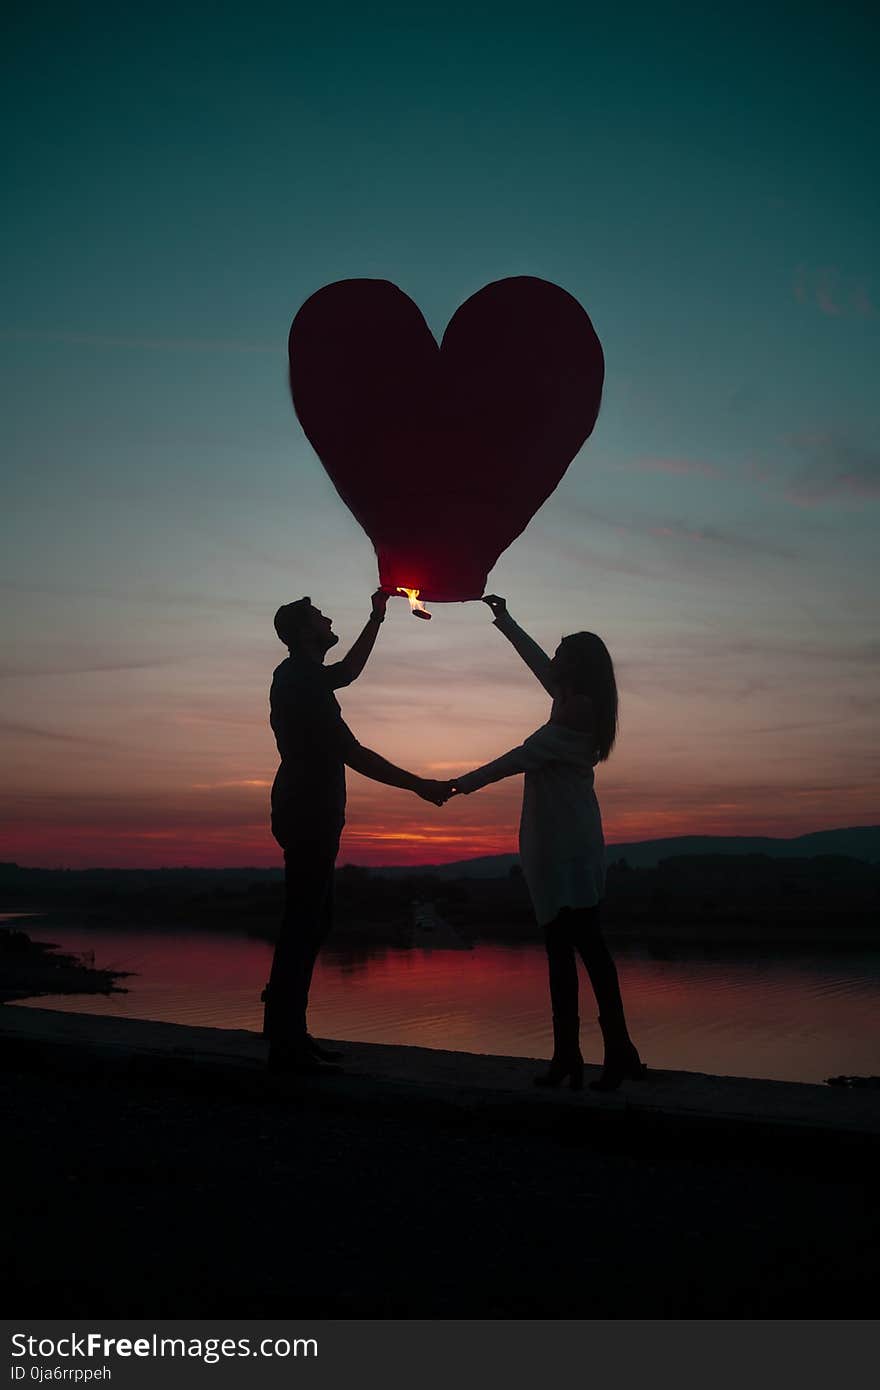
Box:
[0,0,880,867]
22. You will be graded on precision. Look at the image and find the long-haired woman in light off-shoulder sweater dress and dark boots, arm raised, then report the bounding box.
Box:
[449,594,646,1091]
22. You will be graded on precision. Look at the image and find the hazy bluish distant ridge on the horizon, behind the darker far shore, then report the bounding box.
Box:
[371,826,880,878]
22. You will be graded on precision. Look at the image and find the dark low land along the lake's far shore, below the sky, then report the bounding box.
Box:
[0,827,880,945]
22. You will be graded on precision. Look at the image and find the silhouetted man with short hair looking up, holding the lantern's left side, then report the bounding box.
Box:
[263,589,445,1072]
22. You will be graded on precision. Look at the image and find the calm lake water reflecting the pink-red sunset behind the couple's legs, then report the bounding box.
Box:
[3,917,880,1081]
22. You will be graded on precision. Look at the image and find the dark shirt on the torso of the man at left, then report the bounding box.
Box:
[268,656,357,842]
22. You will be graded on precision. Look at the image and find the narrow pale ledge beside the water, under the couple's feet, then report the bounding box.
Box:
[6,1005,880,1147]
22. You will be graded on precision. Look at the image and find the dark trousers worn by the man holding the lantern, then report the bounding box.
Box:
[263,821,342,1043]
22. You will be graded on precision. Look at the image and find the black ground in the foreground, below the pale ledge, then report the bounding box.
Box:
[0,1049,880,1318]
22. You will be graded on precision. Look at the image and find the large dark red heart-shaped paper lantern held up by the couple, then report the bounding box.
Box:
[289,275,605,602]
